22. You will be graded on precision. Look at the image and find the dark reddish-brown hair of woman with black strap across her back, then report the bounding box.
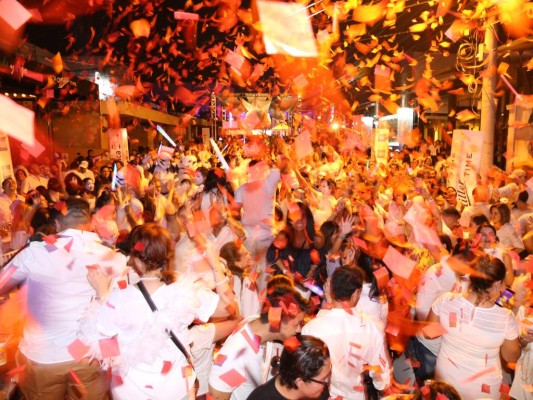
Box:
[127,223,175,285]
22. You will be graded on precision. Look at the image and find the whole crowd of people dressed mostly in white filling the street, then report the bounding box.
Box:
[0,137,533,400]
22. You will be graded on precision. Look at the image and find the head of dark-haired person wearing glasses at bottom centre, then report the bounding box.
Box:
[278,335,331,399]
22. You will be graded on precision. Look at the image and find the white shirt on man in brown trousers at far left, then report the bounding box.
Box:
[4,229,126,364]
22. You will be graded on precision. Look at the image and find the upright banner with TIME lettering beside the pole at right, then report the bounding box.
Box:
[448,129,485,206]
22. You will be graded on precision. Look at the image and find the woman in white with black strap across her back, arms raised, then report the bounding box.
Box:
[80,224,237,400]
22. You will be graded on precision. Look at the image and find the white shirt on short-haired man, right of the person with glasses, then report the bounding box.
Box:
[302,308,391,400]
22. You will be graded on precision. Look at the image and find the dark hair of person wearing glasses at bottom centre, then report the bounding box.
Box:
[279,334,329,389]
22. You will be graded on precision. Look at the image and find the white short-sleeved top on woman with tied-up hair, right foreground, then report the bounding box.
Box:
[431,293,518,399]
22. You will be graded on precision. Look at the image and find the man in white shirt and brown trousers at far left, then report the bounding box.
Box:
[0,198,126,400]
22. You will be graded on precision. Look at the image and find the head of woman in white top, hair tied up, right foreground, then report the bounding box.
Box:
[470,255,506,300]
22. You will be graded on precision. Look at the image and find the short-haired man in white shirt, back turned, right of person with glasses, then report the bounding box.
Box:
[302,266,391,400]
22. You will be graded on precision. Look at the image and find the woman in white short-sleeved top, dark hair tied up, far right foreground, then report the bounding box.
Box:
[428,255,520,400]
